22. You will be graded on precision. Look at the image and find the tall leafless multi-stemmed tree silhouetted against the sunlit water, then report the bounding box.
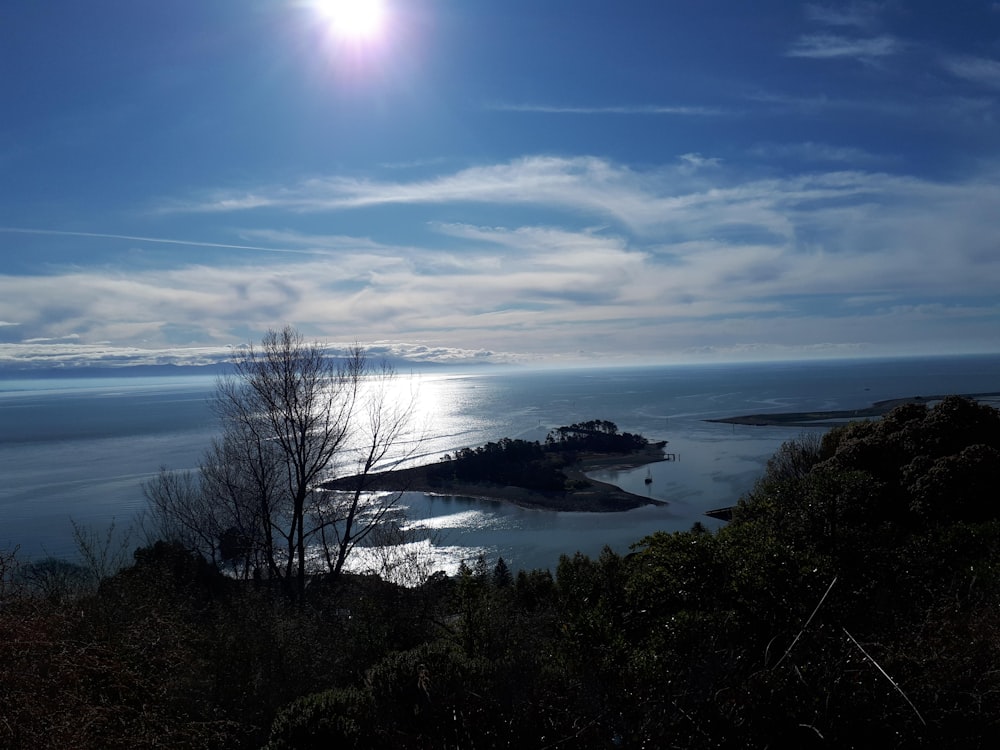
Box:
[145,327,414,595]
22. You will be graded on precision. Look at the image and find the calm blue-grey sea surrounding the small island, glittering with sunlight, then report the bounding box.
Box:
[0,355,1000,572]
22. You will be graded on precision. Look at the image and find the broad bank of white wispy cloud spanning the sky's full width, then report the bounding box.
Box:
[7,156,1000,364]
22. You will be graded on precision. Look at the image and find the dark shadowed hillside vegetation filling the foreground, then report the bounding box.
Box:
[0,397,1000,750]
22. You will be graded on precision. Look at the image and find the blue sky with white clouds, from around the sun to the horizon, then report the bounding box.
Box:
[0,0,1000,366]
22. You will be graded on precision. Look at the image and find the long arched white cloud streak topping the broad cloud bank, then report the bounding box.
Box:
[174,155,916,233]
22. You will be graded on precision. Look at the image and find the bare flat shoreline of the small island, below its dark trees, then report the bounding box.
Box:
[324,442,667,513]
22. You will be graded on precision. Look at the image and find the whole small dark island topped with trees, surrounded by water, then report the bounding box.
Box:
[324,420,666,513]
